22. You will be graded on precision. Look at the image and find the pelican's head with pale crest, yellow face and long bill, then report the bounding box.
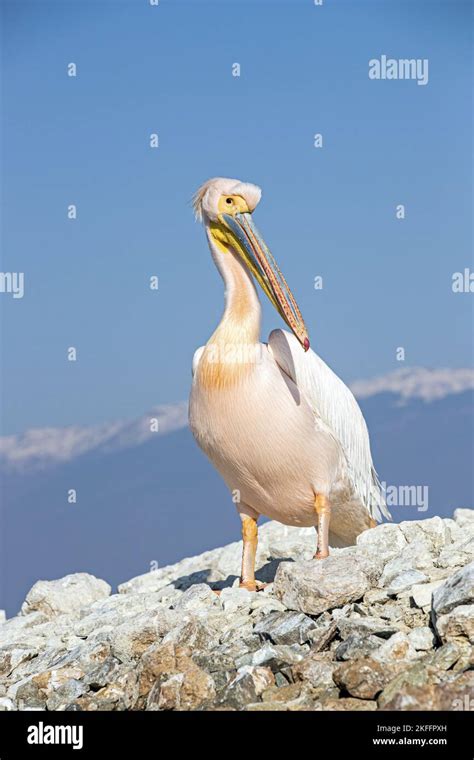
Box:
[193,177,309,351]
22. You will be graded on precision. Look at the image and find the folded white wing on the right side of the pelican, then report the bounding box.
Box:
[268,330,390,522]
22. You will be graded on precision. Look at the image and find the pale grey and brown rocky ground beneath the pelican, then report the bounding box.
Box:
[0,509,474,710]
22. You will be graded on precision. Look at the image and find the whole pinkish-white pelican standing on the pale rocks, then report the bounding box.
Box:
[189,178,390,591]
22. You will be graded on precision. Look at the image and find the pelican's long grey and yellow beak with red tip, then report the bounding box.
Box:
[219,208,309,351]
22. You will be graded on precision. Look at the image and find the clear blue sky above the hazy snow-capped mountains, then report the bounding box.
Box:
[0,0,472,433]
